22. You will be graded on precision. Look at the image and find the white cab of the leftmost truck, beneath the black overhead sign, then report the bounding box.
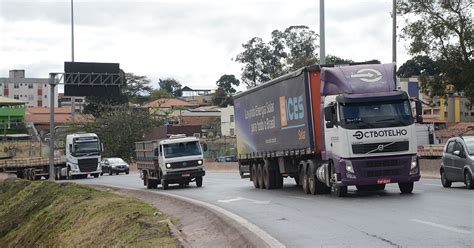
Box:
[60,133,103,179]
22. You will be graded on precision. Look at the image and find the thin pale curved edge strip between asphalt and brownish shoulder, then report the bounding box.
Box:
[95,184,286,248]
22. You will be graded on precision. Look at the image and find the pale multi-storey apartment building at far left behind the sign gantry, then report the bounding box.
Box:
[0,70,58,108]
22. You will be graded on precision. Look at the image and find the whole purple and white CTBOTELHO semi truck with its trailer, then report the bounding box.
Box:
[234,63,422,197]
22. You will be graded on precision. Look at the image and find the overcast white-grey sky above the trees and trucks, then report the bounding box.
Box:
[0,0,410,89]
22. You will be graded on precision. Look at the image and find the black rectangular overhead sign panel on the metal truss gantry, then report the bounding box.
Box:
[64,62,122,96]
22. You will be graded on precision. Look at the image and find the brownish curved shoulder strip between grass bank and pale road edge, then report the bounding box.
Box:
[90,186,265,247]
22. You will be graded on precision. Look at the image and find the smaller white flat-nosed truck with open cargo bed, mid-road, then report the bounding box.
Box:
[135,135,206,190]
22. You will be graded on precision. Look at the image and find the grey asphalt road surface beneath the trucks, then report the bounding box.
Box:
[75,173,474,247]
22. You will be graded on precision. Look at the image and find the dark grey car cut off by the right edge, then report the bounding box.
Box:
[440,136,474,189]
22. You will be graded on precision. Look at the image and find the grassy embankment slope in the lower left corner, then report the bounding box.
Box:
[0,179,178,247]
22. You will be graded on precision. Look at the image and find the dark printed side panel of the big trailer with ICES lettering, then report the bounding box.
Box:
[234,73,314,158]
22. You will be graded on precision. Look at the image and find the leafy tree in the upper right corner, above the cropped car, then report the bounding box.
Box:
[397,0,474,102]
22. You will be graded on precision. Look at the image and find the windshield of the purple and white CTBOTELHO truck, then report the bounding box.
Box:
[339,100,413,129]
